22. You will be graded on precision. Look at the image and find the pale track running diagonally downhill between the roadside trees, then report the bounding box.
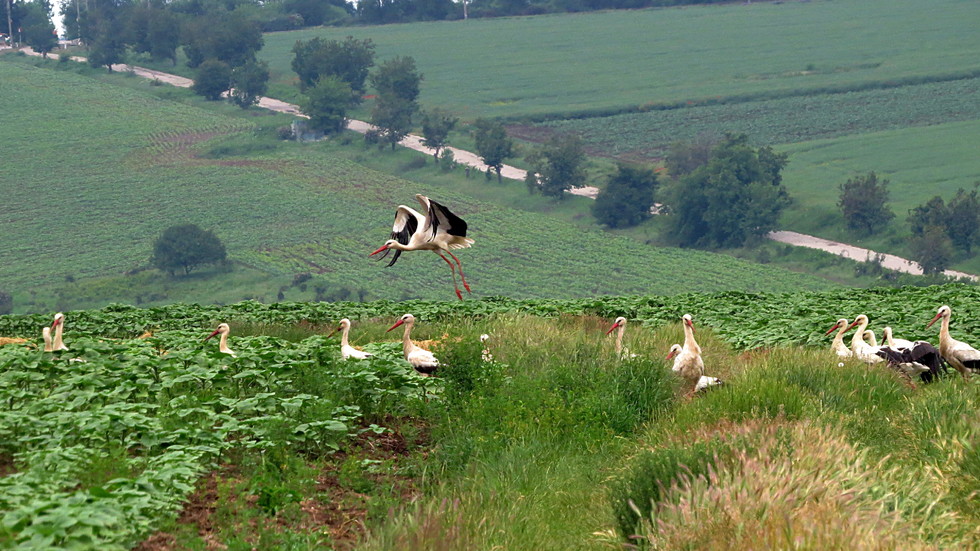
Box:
[22,48,980,281]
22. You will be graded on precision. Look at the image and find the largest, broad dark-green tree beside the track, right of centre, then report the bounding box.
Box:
[667,135,790,247]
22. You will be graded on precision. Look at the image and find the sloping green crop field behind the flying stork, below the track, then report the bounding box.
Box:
[0,58,831,310]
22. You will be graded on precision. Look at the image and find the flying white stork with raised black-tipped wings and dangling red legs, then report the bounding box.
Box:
[369,195,474,300]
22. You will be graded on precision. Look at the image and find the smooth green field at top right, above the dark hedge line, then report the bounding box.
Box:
[260,0,980,120]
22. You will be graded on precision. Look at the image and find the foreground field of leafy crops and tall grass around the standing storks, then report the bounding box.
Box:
[0,285,980,550]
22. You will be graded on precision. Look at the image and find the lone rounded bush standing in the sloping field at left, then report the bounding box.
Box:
[150,224,227,275]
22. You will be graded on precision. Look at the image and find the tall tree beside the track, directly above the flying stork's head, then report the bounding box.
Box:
[371,57,422,150]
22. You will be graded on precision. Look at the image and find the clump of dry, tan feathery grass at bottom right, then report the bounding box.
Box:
[640,422,956,550]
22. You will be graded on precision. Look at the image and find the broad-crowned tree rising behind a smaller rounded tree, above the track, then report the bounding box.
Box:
[291,36,374,98]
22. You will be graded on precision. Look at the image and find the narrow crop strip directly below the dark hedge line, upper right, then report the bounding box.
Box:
[524,78,980,162]
